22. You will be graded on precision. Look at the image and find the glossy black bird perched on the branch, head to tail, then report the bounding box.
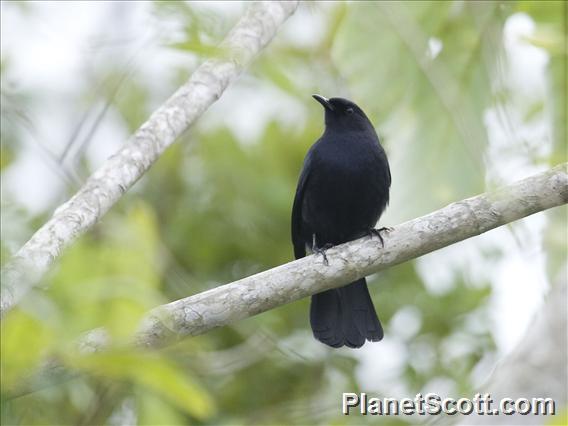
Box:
[292,95,391,348]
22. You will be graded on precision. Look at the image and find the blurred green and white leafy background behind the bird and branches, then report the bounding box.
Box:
[1,1,567,424]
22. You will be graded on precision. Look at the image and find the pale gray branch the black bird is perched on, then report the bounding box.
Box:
[127,163,568,349]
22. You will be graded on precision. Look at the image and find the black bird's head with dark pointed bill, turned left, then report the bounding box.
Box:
[312,95,373,130]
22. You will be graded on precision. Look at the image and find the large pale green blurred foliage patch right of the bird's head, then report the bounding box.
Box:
[332,2,505,213]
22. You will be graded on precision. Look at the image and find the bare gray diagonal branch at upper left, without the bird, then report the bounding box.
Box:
[0,1,298,314]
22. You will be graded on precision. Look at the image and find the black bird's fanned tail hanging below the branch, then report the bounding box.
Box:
[310,278,383,348]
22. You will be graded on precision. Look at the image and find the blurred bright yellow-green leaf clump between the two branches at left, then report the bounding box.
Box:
[49,202,164,340]
